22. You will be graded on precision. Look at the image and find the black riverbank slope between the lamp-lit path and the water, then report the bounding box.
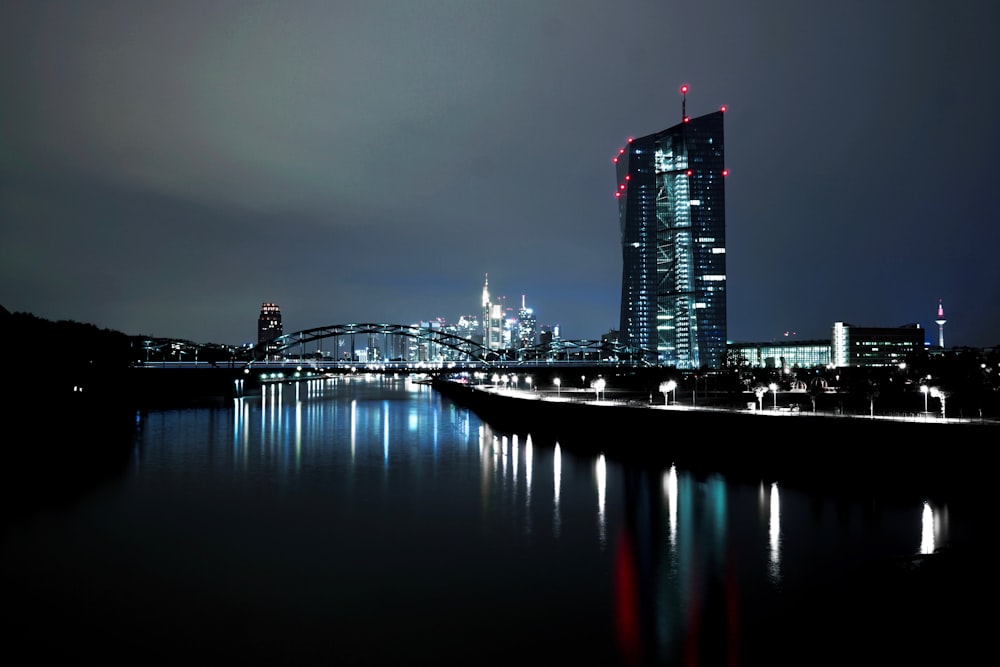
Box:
[435,380,1000,504]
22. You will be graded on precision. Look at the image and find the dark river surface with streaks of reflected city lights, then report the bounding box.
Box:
[0,378,979,665]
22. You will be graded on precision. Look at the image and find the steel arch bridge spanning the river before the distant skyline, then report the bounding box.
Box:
[268,323,648,365]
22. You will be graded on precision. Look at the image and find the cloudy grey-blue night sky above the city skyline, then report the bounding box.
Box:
[0,0,1000,347]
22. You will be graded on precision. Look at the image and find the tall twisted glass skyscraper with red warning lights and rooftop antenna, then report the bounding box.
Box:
[614,86,727,369]
